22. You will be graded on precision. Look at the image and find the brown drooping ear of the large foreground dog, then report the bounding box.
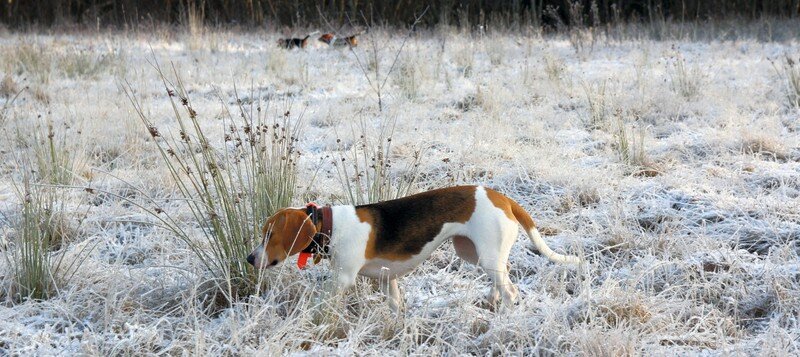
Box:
[271,209,317,256]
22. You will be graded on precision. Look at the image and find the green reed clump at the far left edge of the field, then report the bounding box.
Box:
[0,123,92,302]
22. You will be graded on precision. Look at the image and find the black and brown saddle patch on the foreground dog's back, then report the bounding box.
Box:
[356,186,476,261]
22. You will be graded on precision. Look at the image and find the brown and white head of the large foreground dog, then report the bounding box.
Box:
[247,208,317,269]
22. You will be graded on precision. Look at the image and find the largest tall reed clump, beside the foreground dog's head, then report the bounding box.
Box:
[123,64,302,305]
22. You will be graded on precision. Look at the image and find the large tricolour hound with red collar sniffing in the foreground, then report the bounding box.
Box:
[247,186,581,312]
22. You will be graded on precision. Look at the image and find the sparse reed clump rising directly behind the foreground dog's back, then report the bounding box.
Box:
[334,120,422,205]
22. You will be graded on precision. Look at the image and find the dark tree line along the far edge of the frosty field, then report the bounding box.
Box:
[0,0,800,28]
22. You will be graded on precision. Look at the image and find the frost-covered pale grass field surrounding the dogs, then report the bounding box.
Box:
[0,25,800,355]
